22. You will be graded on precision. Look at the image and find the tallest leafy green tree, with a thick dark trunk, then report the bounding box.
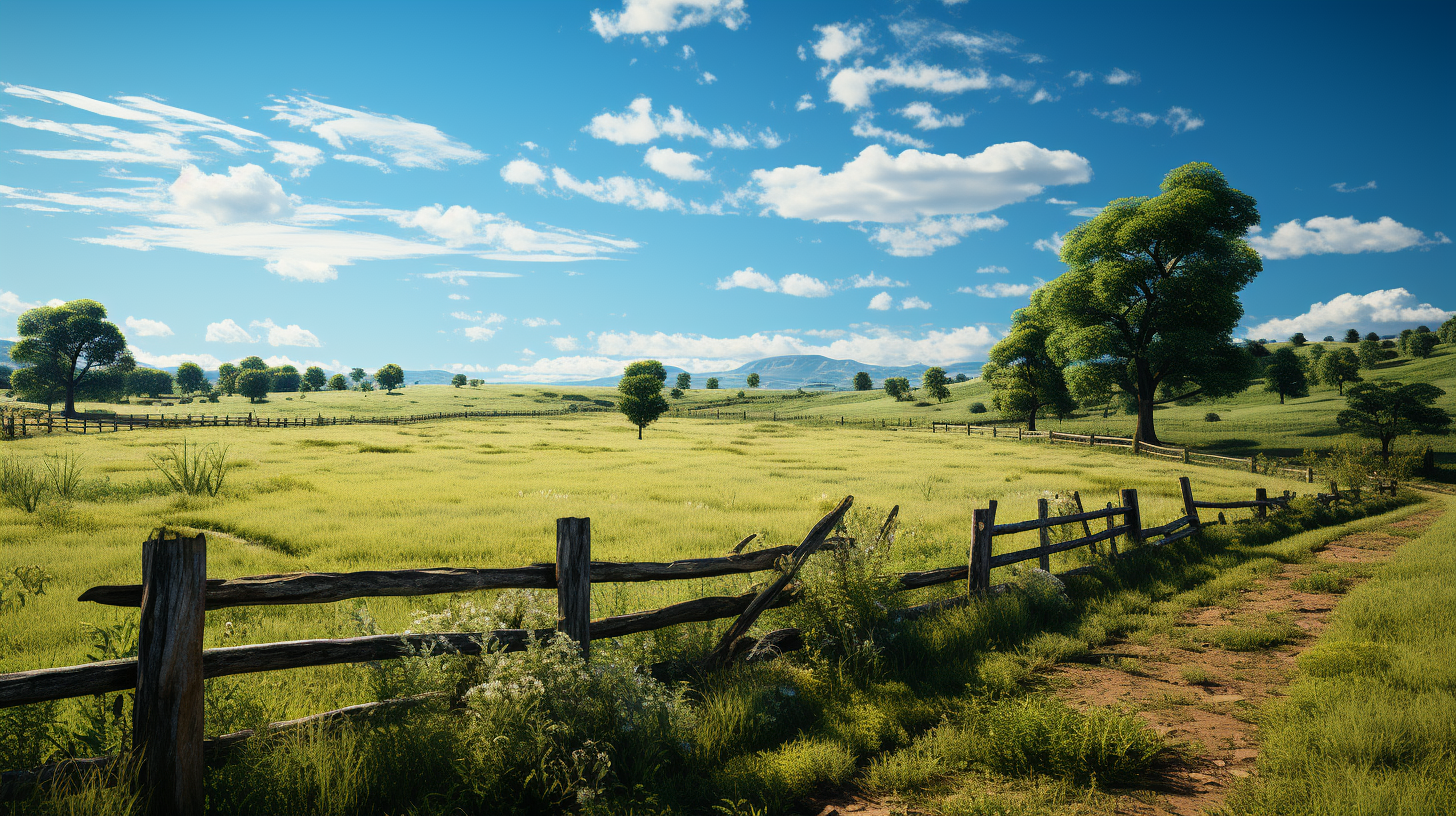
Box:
[1041,162,1264,443]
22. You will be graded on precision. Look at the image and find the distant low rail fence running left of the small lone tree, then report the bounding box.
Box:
[0,405,607,439]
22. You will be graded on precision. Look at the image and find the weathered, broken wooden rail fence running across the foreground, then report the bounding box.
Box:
[0,476,1368,815]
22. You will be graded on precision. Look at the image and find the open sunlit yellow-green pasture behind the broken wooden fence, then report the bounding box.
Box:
[0,414,1300,710]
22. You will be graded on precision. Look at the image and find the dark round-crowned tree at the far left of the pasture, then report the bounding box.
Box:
[10,300,130,417]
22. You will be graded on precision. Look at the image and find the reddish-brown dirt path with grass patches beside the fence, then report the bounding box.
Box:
[1053,510,1441,816]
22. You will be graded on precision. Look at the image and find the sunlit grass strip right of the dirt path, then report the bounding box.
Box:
[1230,486,1456,816]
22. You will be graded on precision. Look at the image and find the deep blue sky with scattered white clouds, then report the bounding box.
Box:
[0,0,1456,382]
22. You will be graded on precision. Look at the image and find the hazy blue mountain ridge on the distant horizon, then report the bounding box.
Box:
[559,354,983,391]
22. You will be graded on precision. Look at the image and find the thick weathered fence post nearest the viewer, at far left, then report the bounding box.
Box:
[131,527,207,816]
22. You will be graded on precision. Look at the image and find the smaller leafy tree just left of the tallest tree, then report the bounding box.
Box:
[981,303,1077,431]
